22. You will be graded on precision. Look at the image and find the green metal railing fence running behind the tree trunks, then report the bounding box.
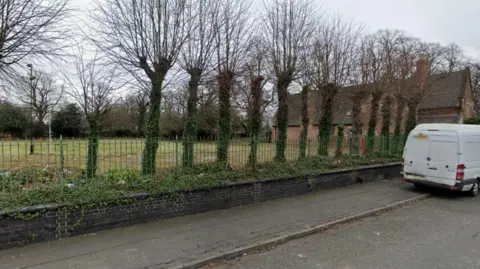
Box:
[0,136,404,174]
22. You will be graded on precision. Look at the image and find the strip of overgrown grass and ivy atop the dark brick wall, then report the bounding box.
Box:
[0,153,399,211]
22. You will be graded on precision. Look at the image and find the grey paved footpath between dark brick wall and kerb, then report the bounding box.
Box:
[0,179,426,269]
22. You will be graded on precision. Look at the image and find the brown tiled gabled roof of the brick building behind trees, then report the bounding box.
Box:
[274,68,470,126]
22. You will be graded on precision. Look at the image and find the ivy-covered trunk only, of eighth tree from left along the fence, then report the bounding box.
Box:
[317,84,337,156]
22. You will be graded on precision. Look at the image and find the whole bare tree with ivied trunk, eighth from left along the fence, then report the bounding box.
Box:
[312,15,362,155]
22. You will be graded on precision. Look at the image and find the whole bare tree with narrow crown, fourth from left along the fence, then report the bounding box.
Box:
[214,0,252,164]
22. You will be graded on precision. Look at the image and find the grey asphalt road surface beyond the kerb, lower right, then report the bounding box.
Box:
[214,188,480,269]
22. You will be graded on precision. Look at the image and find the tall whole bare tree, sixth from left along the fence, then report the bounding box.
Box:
[262,0,318,162]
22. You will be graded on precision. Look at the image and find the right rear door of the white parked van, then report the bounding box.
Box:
[427,132,459,186]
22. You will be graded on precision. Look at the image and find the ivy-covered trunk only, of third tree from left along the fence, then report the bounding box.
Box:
[182,68,202,167]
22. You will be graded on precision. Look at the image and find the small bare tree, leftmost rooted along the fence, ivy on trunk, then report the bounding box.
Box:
[69,47,120,178]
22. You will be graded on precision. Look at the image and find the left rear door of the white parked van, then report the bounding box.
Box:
[403,130,430,179]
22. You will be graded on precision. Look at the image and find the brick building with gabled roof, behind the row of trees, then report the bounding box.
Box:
[272,58,473,139]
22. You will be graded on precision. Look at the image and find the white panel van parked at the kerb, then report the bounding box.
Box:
[402,123,480,196]
